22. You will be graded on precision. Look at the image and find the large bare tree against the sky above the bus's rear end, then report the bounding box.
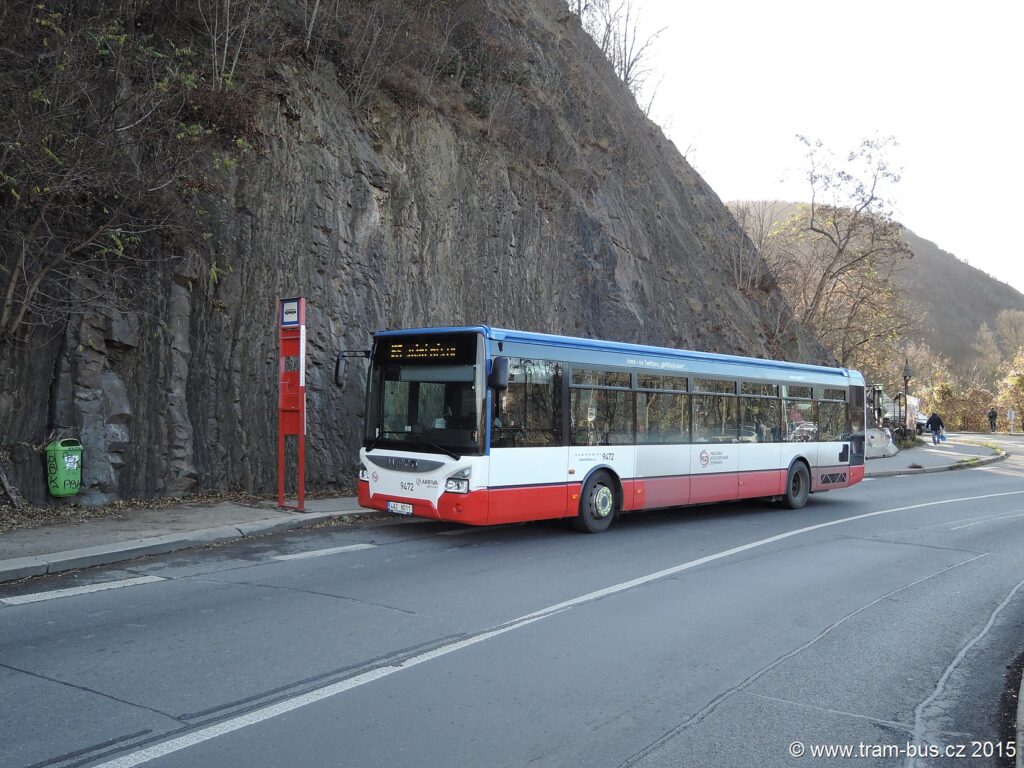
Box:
[737,137,912,376]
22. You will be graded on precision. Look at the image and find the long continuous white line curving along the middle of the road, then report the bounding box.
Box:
[90,490,1024,768]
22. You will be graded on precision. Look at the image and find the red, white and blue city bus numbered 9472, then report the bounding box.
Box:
[348,326,865,532]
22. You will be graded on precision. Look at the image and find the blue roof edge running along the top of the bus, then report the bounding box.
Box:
[376,326,864,384]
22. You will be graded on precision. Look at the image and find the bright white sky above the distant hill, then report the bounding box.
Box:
[634,0,1024,292]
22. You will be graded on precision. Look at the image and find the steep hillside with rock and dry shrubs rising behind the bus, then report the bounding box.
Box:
[0,0,825,503]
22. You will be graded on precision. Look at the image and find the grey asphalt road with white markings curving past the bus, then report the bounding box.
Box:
[0,438,1024,768]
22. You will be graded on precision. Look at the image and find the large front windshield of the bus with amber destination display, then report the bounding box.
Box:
[364,334,483,456]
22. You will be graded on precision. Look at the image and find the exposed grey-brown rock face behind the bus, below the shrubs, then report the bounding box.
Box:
[0,0,824,503]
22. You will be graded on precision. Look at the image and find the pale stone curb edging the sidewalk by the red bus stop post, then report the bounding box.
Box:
[0,509,371,583]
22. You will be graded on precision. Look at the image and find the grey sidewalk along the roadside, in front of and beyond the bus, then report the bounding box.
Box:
[0,438,1006,583]
